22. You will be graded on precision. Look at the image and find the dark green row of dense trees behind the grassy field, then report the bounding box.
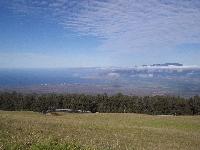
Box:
[0,92,200,115]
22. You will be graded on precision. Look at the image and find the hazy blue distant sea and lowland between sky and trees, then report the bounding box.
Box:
[0,64,200,97]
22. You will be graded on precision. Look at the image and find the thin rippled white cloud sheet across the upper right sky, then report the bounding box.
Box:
[4,0,200,51]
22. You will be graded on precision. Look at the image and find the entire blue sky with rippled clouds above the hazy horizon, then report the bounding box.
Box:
[0,0,200,68]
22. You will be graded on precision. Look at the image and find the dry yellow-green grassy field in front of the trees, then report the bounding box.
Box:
[0,111,200,150]
